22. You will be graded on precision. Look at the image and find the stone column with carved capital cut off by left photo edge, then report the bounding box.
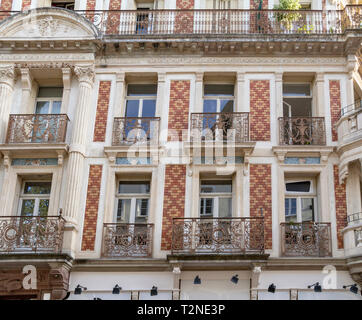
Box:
[0,65,15,143]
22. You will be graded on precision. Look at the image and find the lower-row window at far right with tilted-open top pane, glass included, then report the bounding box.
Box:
[285,180,317,222]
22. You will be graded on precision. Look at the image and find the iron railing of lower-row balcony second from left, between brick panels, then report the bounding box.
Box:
[102,223,153,258]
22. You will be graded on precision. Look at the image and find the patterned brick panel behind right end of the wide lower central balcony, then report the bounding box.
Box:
[250,164,272,249]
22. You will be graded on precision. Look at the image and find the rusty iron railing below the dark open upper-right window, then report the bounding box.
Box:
[279,117,326,145]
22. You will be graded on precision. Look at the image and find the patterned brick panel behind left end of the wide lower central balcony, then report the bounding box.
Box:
[161,164,186,250]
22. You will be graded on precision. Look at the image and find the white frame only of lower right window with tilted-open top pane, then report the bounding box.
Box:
[284,178,319,223]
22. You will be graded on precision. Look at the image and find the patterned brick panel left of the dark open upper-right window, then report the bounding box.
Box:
[250,80,270,141]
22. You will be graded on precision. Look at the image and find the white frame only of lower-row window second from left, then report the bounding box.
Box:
[113,180,151,224]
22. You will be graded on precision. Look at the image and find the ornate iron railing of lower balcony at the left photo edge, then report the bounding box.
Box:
[0,216,65,254]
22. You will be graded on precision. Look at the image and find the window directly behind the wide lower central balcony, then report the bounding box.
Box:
[200,180,232,218]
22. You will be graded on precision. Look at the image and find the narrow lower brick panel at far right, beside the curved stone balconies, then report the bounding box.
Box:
[333,165,347,249]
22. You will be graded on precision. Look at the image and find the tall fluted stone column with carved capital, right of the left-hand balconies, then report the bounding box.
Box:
[64,65,94,225]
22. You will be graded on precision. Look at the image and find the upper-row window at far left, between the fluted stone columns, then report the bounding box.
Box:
[35,87,63,114]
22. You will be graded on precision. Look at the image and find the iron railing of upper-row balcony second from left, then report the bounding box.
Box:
[112,118,160,146]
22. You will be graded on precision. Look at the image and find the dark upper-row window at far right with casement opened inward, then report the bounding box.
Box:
[283,83,312,117]
